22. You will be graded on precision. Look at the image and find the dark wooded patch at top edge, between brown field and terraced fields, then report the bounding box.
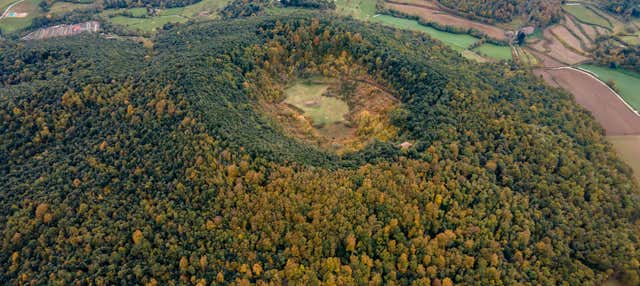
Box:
[439,0,562,27]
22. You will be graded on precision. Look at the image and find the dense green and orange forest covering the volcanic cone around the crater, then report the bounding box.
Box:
[0,15,640,285]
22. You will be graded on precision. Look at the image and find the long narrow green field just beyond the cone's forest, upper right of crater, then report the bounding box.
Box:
[371,15,478,51]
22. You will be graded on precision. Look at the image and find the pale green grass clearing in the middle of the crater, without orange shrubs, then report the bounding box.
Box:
[284,80,349,126]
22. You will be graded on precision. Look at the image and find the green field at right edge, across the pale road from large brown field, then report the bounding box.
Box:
[580,65,640,110]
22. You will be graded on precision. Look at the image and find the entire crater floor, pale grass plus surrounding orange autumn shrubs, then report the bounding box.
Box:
[266,77,396,154]
